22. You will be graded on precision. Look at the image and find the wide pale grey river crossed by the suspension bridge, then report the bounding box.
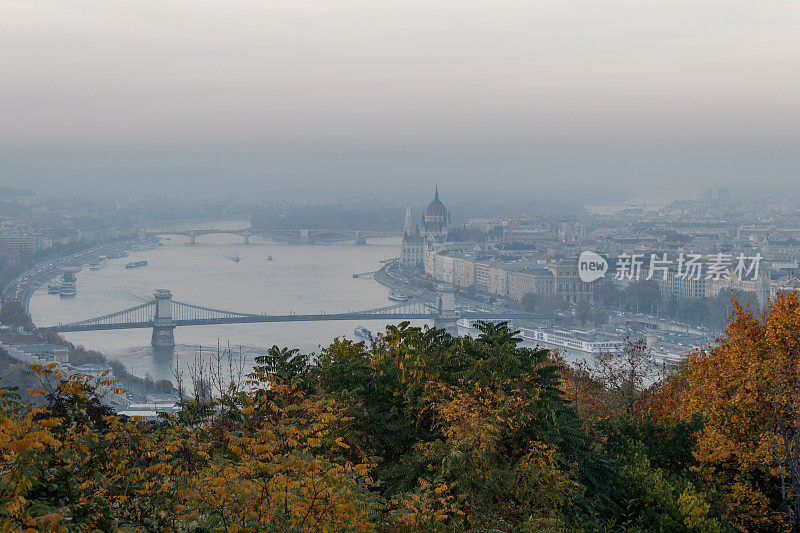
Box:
[30,223,432,379]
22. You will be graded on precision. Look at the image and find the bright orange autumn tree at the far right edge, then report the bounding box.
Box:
[675,294,800,531]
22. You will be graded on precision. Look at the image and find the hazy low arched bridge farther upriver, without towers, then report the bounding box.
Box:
[146,228,403,244]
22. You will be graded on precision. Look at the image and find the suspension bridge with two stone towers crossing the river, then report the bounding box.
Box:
[40,285,532,346]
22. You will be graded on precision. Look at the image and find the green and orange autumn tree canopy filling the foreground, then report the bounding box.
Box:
[6,297,800,531]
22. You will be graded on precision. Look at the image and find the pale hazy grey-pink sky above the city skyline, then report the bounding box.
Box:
[0,0,800,194]
